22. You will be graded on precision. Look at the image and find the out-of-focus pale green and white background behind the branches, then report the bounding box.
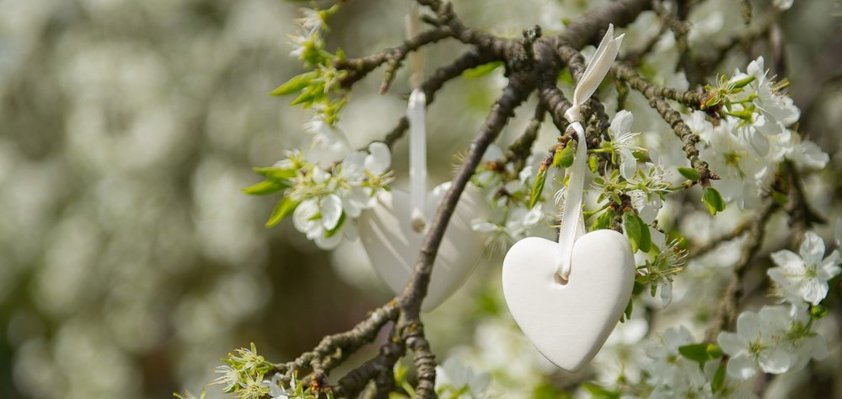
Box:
[0,0,842,399]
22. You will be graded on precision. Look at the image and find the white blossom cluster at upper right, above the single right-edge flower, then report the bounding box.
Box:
[686,57,829,208]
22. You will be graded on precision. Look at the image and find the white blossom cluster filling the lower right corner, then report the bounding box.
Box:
[639,228,842,398]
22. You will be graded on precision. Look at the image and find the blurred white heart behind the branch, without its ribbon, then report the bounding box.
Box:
[358,183,485,311]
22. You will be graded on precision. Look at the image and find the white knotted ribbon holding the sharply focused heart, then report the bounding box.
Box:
[557,25,625,281]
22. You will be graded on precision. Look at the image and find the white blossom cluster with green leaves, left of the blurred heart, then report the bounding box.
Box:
[244,119,391,249]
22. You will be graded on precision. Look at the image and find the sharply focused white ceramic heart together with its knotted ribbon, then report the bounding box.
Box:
[503,26,635,371]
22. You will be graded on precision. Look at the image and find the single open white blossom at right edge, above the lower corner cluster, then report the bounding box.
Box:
[767,231,842,305]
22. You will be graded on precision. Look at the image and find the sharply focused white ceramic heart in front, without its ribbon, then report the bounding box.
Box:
[503,230,635,371]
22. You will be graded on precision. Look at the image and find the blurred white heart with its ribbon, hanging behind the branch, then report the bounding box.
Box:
[357,90,486,311]
